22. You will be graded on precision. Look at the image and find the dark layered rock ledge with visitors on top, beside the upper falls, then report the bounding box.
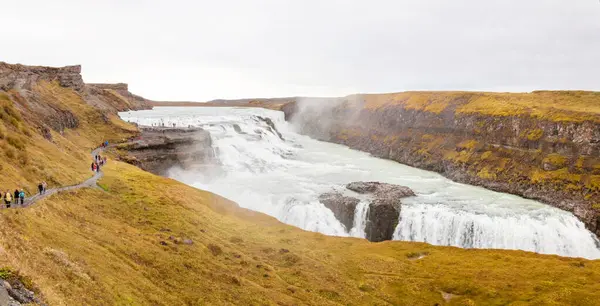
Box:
[118,127,215,175]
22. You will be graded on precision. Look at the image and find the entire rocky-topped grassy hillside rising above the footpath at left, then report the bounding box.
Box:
[0,62,146,194]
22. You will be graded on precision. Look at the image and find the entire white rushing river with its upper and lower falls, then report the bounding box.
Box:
[120,107,600,259]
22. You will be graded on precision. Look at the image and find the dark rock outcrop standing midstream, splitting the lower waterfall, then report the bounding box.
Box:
[319,182,415,242]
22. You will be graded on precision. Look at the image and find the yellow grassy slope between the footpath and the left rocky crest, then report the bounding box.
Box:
[0,82,136,194]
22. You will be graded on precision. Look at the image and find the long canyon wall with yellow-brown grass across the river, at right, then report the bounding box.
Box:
[282,92,600,234]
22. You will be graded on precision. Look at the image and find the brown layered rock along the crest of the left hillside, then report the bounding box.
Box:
[0,62,150,140]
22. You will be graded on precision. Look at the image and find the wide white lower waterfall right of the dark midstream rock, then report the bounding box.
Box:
[394,205,600,258]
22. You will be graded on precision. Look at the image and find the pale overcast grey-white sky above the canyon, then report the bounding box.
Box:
[0,0,600,101]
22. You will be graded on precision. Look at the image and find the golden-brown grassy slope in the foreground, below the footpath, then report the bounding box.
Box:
[0,161,600,305]
